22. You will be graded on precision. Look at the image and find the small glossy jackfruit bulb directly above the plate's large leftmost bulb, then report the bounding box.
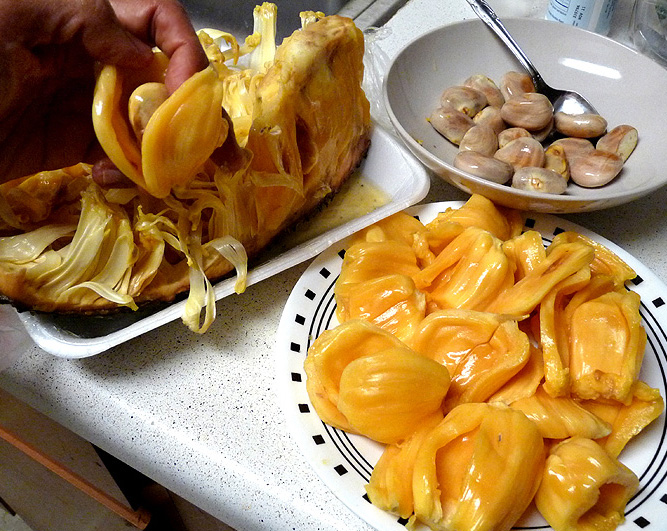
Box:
[336,275,426,341]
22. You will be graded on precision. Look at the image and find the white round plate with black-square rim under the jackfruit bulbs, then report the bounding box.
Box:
[276,202,667,531]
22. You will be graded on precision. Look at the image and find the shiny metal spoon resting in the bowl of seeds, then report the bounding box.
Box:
[468,0,599,114]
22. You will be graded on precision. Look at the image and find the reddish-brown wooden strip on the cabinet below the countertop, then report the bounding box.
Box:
[0,426,151,529]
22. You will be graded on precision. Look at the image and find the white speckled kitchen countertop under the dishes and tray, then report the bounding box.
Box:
[0,0,667,531]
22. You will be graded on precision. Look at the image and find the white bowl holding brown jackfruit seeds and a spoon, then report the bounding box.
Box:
[383,19,667,213]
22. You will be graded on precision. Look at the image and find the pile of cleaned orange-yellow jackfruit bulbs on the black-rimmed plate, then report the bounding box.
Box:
[304,195,664,531]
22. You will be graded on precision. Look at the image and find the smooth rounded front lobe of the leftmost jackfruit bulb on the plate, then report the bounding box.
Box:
[338,347,450,444]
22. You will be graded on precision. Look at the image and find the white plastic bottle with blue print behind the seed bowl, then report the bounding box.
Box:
[547,0,616,35]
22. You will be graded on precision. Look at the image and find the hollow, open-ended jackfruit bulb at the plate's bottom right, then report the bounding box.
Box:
[535,437,639,531]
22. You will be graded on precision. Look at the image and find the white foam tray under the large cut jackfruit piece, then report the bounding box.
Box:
[20,127,430,358]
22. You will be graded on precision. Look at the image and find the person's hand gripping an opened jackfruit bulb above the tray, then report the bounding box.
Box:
[0,0,208,182]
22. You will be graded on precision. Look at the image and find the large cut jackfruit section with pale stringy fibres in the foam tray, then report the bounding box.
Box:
[0,3,370,332]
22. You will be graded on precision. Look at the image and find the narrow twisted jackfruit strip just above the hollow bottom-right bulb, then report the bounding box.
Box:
[511,387,611,439]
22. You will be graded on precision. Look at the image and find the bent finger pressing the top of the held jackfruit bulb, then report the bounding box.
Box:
[111,0,208,93]
